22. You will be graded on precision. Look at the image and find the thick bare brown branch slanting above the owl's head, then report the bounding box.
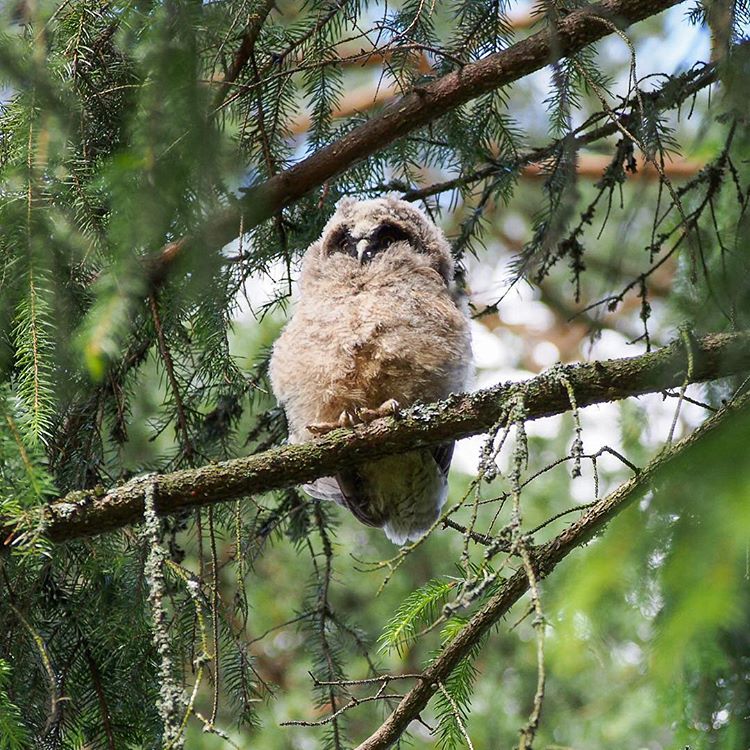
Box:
[165,0,682,262]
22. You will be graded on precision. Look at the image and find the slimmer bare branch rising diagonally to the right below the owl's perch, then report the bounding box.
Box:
[356,388,750,750]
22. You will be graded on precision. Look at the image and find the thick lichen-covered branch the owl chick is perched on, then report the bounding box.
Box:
[10,332,750,542]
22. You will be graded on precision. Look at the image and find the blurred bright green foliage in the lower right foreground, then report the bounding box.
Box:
[555,415,750,748]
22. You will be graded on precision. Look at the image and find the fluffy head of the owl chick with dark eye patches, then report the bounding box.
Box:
[304,197,453,285]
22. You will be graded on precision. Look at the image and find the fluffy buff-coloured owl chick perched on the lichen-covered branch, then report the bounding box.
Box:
[270,198,471,544]
